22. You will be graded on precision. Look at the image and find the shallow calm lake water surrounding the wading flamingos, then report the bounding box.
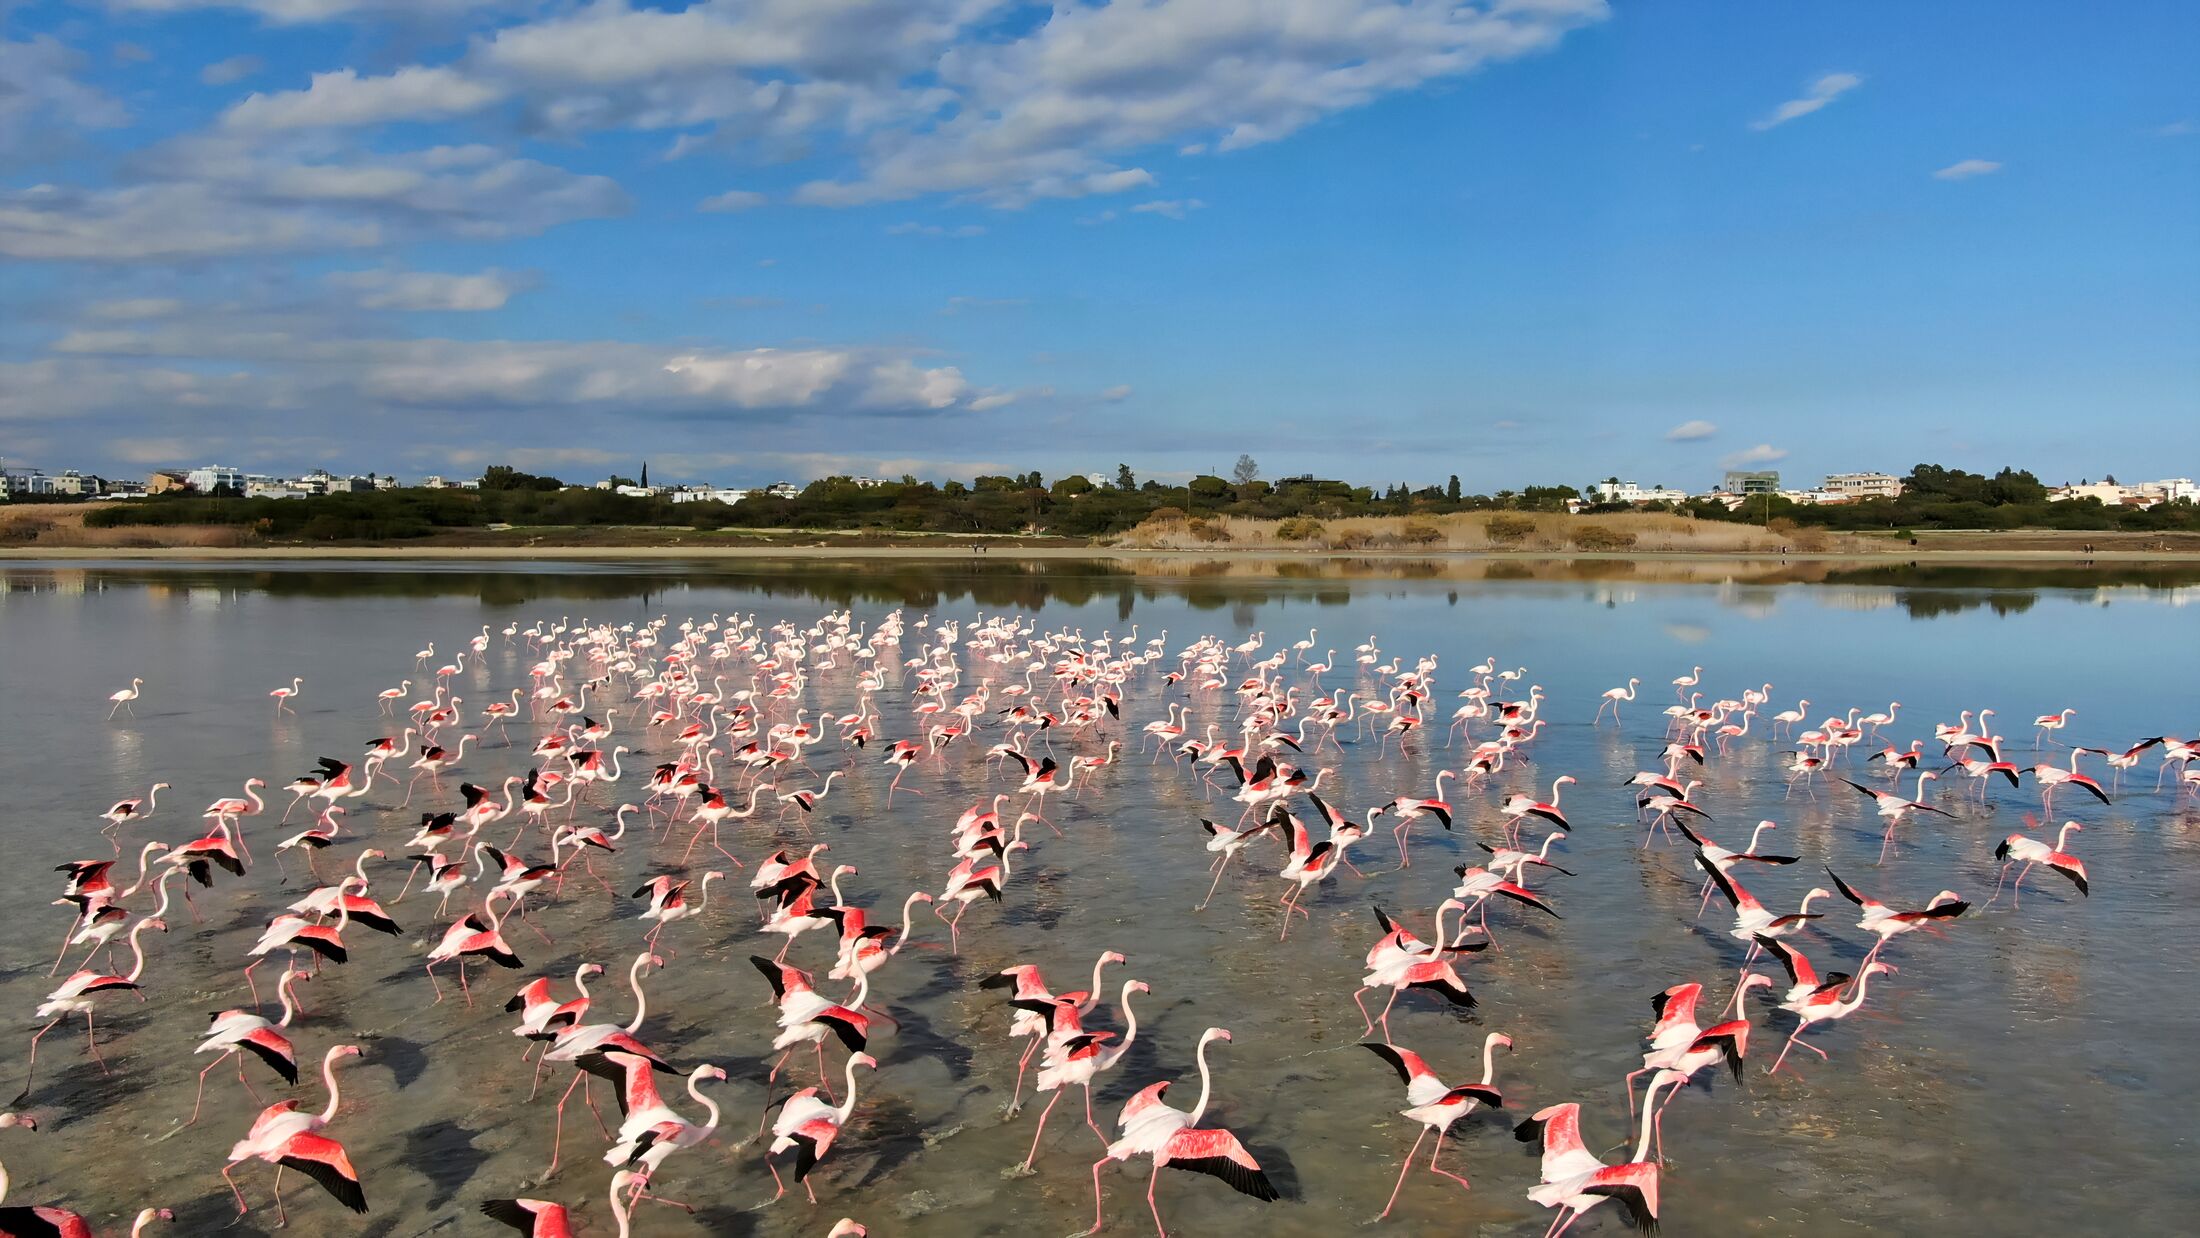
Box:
[0,563,2200,1238]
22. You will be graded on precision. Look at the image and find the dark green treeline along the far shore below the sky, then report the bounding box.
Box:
[73,462,2200,541]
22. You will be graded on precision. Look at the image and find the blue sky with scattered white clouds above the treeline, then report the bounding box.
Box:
[0,0,2200,490]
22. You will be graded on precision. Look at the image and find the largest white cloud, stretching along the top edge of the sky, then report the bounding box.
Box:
[214,0,1610,207]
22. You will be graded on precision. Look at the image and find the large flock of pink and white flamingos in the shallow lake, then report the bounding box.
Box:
[0,611,2200,1238]
